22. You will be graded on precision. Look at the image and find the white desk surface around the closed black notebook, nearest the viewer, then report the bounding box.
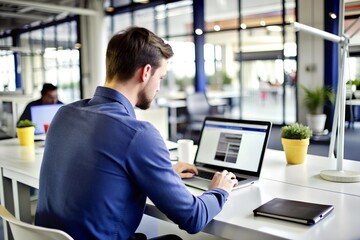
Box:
[146,179,360,240]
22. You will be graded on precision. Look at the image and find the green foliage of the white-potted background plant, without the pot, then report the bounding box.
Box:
[301,86,335,114]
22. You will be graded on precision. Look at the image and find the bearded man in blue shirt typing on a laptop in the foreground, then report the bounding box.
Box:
[35,27,237,240]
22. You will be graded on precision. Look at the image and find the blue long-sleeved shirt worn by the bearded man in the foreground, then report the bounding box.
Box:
[35,87,228,239]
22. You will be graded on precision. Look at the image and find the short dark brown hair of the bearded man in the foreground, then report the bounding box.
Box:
[106,27,174,80]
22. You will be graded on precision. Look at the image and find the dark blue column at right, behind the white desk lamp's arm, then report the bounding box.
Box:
[324,0,340,130]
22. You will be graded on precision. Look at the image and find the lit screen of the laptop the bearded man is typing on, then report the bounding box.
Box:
[195,118,271,173]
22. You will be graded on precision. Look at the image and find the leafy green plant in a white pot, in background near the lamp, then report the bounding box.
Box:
[302,86,335,133]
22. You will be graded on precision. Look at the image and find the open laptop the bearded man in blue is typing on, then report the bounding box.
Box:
[183,117,272,190]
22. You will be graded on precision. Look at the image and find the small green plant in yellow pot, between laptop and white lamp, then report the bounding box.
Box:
[281,123,312,164]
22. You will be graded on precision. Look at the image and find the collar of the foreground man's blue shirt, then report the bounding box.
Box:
[94,86,136,118]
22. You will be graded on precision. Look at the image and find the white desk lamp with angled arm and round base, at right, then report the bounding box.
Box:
[294,16,360,182]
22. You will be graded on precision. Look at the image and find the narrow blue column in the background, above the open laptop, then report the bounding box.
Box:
[193,0,207,92]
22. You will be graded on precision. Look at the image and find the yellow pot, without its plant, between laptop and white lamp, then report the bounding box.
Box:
[281,138,310,164]
